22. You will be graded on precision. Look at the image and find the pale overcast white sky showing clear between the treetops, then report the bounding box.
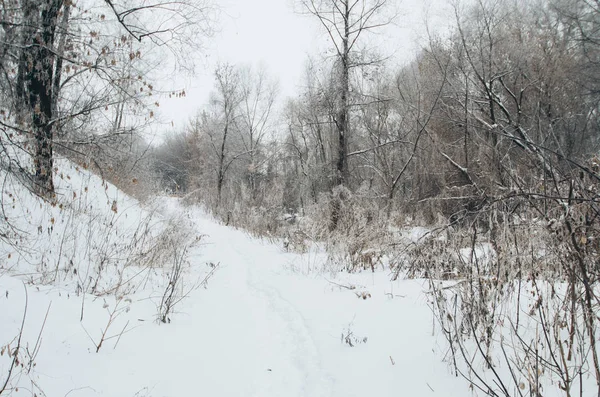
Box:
[161,0,451,129]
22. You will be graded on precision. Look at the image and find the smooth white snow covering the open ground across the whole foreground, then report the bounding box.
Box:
[0,161,470,397]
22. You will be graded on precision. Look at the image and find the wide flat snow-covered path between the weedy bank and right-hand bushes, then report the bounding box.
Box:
[165,206,465,397]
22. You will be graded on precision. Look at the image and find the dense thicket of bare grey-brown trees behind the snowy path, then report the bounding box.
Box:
[153,0,598,251]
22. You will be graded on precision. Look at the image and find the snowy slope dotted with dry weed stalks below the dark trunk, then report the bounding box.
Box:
[0,160,196,294]
